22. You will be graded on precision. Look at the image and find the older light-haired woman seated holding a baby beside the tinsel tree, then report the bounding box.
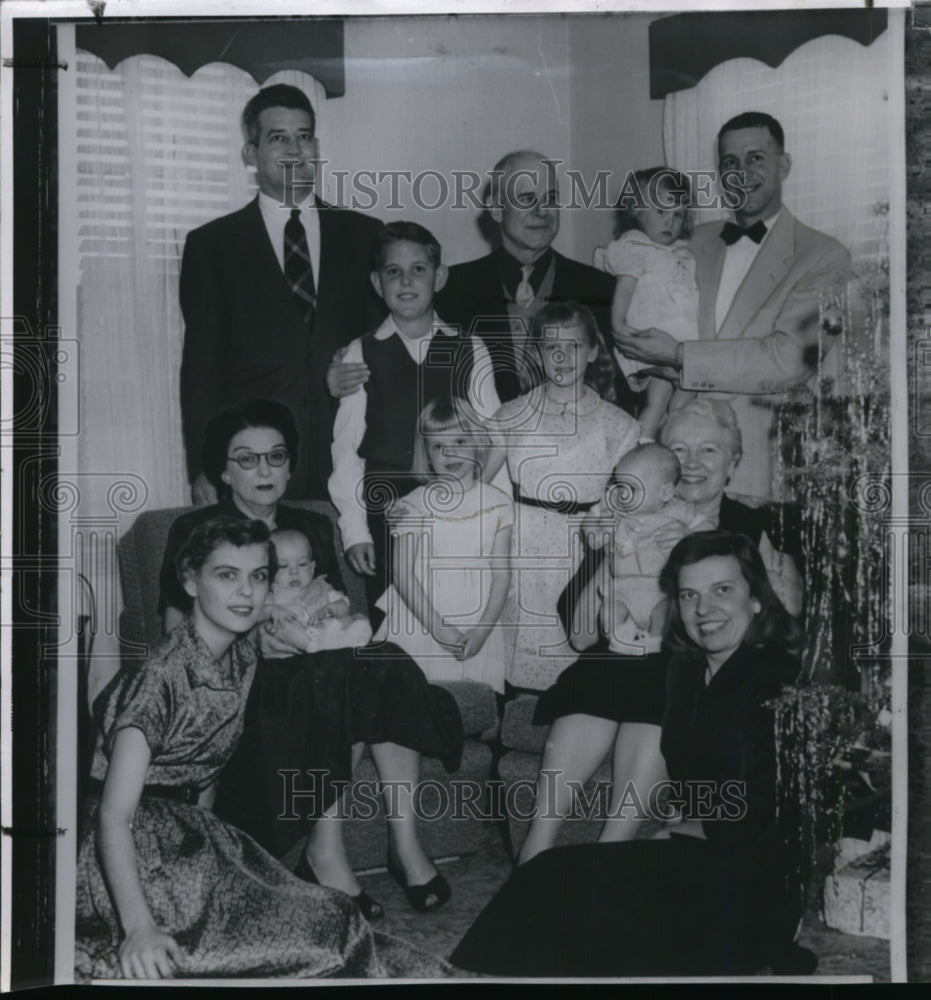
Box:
[519,400,801,863]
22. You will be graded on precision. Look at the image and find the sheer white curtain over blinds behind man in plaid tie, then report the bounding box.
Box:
[59,47,326,697]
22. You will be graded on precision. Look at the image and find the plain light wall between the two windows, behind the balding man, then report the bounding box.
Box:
[321,15,662,263]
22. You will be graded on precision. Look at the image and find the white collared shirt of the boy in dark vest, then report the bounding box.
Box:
[328,313,501,549]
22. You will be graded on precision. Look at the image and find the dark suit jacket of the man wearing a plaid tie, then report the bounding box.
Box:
[181,198,384,499]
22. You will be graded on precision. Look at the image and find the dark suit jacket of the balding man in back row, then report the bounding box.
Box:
[436,249,636,414]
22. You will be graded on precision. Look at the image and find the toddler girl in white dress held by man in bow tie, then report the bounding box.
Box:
[605,167,698,438]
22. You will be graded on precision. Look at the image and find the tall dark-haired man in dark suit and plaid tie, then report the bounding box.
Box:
[181,84,384,504]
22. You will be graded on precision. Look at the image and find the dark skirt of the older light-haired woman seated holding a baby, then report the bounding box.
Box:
[533,642,667,726]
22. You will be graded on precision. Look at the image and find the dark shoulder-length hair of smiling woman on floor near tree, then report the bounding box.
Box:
[659,530,802,654]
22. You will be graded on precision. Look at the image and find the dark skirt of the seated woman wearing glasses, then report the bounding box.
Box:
[214,645,463,856]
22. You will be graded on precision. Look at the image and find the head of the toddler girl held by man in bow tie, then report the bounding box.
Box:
[614,167,691,246]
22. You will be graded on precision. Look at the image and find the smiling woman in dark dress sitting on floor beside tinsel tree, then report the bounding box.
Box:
[451,531,800,977]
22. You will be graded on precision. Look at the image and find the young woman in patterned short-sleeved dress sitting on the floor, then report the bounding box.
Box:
[75,518,448,979]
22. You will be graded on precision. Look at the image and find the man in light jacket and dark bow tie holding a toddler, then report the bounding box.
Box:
[615,111,850,498]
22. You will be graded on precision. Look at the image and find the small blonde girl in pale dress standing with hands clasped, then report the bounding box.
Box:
[375,397,514,693]
